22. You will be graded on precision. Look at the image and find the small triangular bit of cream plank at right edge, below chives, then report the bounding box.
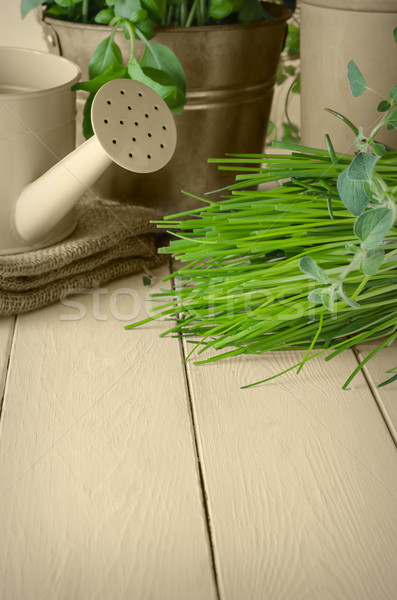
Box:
[357,342,397,443]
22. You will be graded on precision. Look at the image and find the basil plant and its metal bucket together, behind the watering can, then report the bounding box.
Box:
[22,0,291,212]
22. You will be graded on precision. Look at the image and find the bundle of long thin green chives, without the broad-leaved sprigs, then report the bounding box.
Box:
[129,144,397,388]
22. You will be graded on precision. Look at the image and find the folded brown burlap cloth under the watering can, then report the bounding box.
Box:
[0,195,167,316]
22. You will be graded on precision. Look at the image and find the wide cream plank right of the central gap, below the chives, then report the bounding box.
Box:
[184,344,397,600]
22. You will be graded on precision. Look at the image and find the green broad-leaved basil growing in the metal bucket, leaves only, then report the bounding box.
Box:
[21,0,276,138]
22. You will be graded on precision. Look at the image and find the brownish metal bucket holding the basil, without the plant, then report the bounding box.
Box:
[38,2,290,214]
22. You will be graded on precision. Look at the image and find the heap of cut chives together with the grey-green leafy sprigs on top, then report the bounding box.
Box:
[129,28,397,388]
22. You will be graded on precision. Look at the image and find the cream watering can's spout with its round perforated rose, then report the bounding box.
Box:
[15,79,176,244]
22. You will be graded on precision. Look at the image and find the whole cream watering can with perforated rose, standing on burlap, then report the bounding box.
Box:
[0,47,176,254]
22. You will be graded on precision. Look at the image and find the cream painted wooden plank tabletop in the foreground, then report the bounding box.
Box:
[0,267,397,600]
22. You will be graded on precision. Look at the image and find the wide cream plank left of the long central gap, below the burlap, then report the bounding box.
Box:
[0,270,216,600]
